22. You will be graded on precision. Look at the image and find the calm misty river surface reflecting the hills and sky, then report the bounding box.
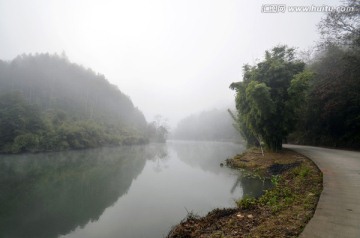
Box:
[0,141,267,238]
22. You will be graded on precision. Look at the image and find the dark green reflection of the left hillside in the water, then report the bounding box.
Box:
[0,146,162,238]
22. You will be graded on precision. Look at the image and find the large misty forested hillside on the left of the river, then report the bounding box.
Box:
[0,54,148,153]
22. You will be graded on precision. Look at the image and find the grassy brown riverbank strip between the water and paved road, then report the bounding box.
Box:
[167,149,322,238]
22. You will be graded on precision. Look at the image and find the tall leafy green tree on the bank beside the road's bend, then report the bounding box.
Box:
[230,46,312,151]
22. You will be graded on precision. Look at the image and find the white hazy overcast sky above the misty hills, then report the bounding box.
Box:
[0,0,340,126]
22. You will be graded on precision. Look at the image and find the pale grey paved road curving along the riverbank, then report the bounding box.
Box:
[284,145,360,238]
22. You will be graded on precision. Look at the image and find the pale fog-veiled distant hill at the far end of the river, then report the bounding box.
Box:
[170,109,241,141]
